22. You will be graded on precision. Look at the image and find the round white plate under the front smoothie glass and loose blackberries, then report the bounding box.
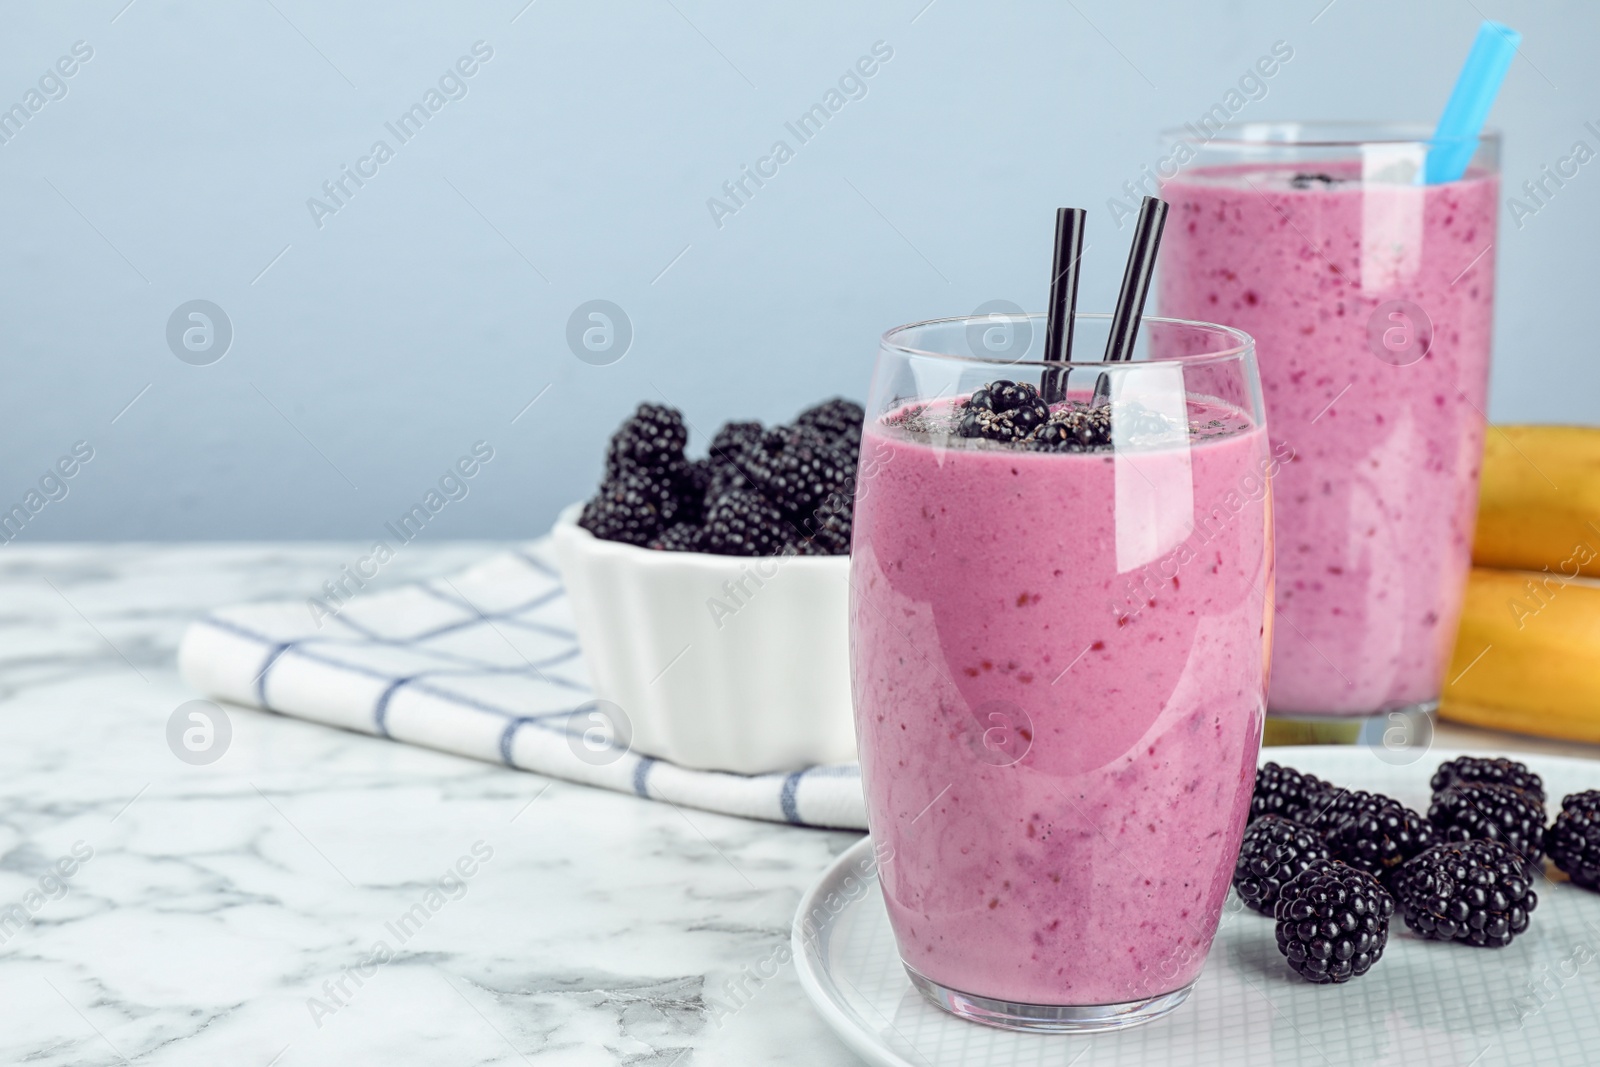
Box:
[794,745,1600,1067]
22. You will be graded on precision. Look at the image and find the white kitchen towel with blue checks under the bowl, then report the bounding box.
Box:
[178,539,867,830]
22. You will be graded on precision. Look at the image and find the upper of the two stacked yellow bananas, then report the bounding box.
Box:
[1472,426,1600,575]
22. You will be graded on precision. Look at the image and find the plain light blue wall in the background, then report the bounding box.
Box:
[0,0,1600,541]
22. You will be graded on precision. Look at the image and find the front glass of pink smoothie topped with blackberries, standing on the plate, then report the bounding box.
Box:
[851,315,1275,1030]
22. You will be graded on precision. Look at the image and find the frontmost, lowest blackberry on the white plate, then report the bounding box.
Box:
[1272,859,1395,984]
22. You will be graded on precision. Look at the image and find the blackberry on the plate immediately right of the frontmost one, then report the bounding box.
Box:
[1394,841,1539,949]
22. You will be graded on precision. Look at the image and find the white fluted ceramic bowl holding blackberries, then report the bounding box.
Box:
[554,506,856,774]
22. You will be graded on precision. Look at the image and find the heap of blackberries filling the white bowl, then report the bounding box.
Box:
[578,397,864,555]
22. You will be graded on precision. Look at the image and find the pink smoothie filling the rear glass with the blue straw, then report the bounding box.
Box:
[1160,163,1499,715]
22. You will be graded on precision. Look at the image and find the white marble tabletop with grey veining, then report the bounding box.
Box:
[0,544,858,1067]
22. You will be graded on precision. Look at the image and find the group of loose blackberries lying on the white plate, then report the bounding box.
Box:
[1234,757,1574,982]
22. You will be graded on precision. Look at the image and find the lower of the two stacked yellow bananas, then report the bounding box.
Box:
[1438,566,1600,742]
